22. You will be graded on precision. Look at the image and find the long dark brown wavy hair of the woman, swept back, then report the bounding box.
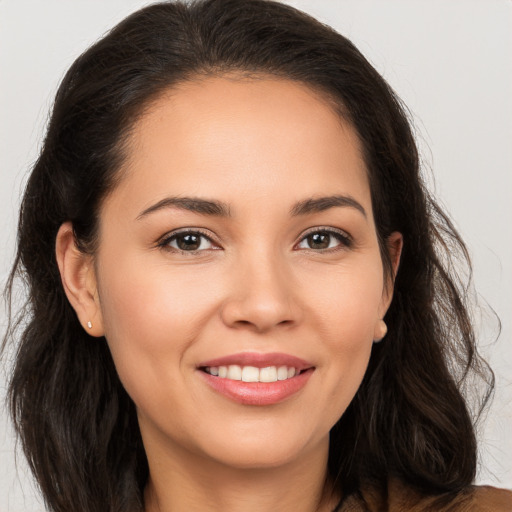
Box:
[4,0,493,512]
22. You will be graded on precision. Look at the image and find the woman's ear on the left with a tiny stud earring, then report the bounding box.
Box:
[55,222,104,336]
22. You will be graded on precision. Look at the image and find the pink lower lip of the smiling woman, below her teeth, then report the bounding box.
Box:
[198,368,314,405]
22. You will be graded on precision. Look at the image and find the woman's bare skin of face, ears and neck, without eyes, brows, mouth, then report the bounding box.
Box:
[57,76,402,512]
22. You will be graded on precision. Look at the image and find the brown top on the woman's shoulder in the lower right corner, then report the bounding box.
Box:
[339,481,512,512]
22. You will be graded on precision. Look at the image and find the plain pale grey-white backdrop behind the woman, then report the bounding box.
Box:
[0,0,512,512]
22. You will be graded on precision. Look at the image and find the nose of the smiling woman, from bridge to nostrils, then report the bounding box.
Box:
[221,253,302,333]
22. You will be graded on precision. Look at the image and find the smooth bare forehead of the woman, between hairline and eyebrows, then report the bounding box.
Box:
[109,76,371,218]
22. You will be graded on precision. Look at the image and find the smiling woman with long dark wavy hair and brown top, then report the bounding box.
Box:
[1,0,510,512]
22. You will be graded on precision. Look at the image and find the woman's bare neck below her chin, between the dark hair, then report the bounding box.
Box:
[145,434,337,512]
